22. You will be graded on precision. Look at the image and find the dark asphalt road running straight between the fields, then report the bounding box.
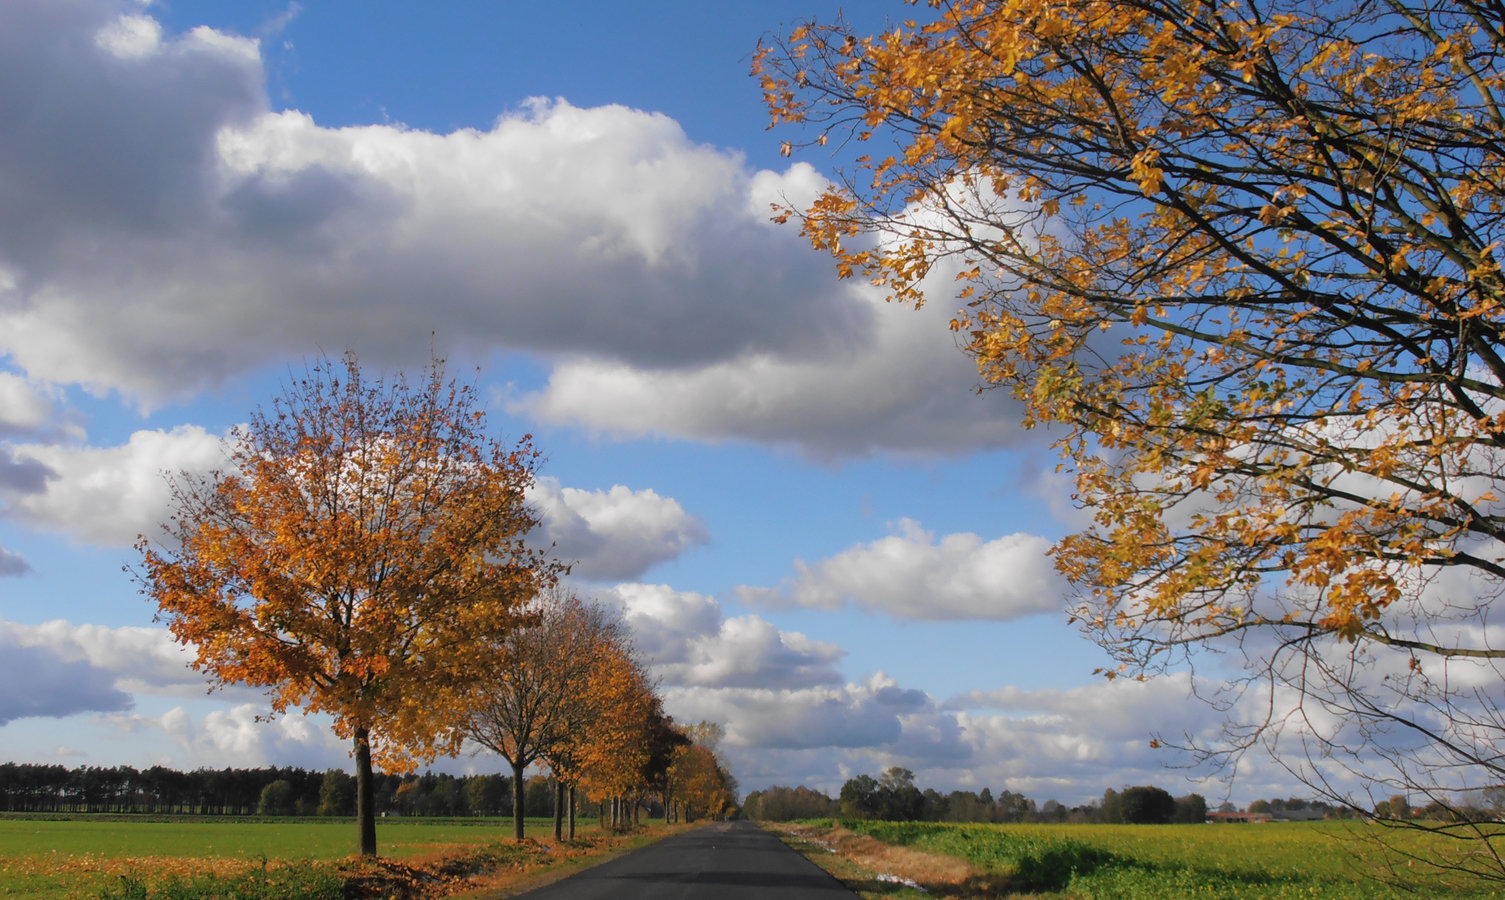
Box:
[516,822,856,900]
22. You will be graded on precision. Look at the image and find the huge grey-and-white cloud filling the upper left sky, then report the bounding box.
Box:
[0,0,1019,458]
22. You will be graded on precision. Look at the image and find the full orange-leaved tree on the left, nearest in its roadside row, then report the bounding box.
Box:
[138,355,558,855]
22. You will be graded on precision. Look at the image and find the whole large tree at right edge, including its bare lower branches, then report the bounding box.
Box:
[756,0,1505,877]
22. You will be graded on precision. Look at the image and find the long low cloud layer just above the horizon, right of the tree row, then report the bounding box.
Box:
[677,673,1276,805]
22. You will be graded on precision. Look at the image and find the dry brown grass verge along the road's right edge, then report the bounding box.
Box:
[759,822,1023,900]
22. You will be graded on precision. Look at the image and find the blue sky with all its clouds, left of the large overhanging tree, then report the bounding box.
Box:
[0,0,1297,802]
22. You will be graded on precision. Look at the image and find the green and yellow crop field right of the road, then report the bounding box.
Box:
[771,820,1505,900]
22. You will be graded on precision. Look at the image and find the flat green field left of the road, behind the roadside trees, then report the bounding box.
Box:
[0,816,641,900]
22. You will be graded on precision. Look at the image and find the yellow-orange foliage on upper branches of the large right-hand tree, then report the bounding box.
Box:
[758,0,1505,704]
